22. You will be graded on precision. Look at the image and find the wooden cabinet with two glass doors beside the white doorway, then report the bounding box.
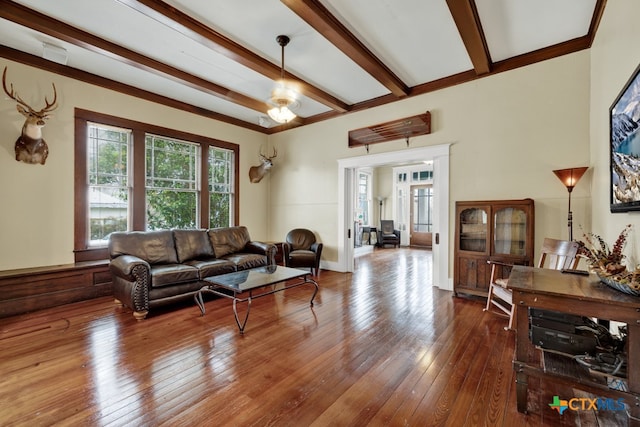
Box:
[453,199,535,296]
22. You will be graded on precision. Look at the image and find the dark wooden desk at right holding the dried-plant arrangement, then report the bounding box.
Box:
[508,266,640,425]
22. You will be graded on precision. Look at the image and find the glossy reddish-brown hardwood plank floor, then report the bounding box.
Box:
[0,248,626,426]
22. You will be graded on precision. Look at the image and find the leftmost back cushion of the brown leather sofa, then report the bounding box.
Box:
[109,230,178,264]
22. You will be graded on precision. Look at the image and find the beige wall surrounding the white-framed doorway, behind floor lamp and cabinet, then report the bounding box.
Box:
[269,51,591,286]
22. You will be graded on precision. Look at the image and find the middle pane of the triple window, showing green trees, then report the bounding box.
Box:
[145,135,200,230]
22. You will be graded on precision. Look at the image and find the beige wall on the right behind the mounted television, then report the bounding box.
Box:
[590,0,640,265]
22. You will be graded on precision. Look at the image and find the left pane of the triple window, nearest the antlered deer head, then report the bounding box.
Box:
[87,123,131,246]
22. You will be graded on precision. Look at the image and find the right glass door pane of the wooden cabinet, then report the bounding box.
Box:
[493,208,527,256]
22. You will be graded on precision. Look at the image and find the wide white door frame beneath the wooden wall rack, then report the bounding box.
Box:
[337,144,453,290]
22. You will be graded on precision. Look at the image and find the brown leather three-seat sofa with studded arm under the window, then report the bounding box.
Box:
[109,226,276,320]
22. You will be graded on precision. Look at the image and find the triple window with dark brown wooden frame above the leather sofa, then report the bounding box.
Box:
[74,109,239,262]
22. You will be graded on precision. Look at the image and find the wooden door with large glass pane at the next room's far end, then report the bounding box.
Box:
[409,185,433,248]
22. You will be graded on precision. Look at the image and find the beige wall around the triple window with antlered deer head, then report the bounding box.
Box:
[0,59,268,270]
